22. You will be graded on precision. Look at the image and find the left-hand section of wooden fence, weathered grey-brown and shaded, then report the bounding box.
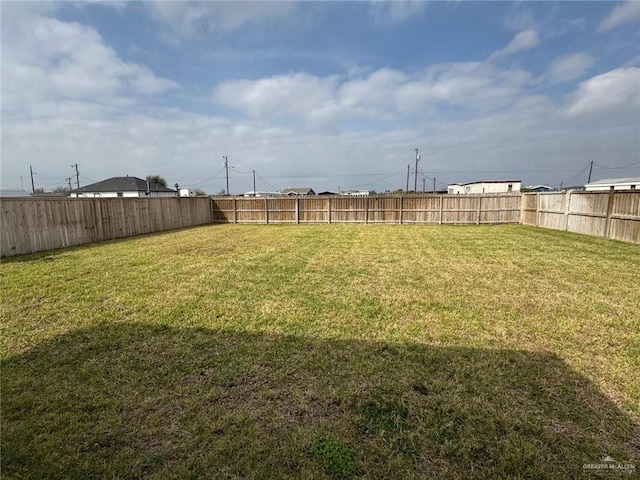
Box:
[0,197,212,257]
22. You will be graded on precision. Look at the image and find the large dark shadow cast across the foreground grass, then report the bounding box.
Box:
[2,324,640,479]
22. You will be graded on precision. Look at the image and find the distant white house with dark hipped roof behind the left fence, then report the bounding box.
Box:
[70,177,177,198]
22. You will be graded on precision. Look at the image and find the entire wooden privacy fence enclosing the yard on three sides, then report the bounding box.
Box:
[0,190,640,257]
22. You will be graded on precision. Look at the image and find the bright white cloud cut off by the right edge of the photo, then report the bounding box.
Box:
[565,67,640,116]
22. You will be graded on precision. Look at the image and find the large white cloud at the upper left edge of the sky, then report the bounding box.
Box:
[2,15,177,118]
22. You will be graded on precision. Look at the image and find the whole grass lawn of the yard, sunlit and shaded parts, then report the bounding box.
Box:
[0,225,640,479]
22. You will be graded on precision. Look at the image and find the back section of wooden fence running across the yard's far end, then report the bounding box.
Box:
[212,195,521,224]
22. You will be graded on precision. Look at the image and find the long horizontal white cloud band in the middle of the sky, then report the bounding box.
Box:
[213,62,532,129]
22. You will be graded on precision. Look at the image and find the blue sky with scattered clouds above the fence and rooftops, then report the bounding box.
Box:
[1,1,640,194]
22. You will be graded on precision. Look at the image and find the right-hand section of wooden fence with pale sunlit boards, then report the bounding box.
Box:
[521,190,640,243]
